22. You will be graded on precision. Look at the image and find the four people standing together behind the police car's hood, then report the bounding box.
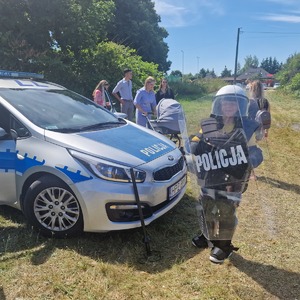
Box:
[93,69,174,127]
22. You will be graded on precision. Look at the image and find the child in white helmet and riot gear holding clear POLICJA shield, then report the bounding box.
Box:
[190,85,263,263]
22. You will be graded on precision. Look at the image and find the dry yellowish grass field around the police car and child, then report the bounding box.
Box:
[0,91,300,300]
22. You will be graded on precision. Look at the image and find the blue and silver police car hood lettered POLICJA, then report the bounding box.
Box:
[45,123,176,165]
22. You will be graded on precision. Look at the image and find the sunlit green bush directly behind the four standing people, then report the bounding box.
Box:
[34,42,162,98]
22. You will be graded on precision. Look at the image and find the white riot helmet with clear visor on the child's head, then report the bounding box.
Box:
[211,85,249,117]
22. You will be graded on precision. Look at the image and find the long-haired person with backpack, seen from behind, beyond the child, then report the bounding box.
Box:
[249,80,271,140]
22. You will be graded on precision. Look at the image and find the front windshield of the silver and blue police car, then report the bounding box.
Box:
[0,89,125,132]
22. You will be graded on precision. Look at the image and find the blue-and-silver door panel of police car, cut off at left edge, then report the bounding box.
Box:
[0,128,17,204]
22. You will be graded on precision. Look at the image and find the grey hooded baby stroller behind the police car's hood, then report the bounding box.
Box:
[149,99,182,148]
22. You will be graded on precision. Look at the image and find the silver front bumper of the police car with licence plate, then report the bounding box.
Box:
[76,166,187,232]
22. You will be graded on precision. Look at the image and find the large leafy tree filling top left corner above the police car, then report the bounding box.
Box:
[0,0,114,70]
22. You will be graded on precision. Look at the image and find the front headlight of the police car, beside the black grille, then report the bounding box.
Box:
[69,150,146,182]
